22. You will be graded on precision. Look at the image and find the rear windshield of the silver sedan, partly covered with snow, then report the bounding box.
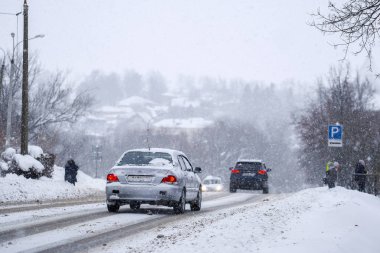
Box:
[117,151,173,166]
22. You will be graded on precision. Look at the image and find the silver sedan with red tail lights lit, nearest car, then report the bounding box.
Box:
[106,148,202,214]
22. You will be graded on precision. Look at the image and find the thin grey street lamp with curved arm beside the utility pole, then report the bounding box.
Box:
[5,33,45,148]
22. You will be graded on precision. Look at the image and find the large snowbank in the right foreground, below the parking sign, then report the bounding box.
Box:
[94,187,380,253]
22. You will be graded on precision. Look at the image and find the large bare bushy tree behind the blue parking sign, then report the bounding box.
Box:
[296,65,380,187]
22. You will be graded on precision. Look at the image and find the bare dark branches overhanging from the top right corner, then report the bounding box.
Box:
[311,0,380,70]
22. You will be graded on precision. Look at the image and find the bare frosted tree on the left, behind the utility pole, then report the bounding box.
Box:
[0,53,93,146]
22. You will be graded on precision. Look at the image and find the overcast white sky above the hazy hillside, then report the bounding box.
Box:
[0,0,376,84]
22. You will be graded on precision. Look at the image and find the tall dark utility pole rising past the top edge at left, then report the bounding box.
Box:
[21,0,29,155]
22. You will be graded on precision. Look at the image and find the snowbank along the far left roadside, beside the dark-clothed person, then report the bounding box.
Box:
[0,166,106,203]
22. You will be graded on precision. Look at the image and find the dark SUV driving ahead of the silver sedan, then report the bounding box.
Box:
[230,160,271,194]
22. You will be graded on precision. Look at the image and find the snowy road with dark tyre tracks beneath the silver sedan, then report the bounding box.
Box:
[0,193,267,252]
